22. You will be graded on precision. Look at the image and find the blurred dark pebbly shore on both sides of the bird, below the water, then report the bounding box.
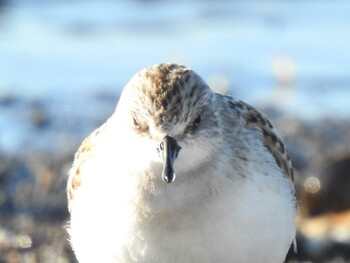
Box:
[0,93,350,263]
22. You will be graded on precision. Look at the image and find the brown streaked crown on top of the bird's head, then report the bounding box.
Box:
[123,64,211,130]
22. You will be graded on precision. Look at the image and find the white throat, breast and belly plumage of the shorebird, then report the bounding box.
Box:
[70,116,295,263]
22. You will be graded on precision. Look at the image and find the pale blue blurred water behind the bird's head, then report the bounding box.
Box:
[0,0,350,153]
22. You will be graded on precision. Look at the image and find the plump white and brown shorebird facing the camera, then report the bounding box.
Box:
[67,64,296,263]
